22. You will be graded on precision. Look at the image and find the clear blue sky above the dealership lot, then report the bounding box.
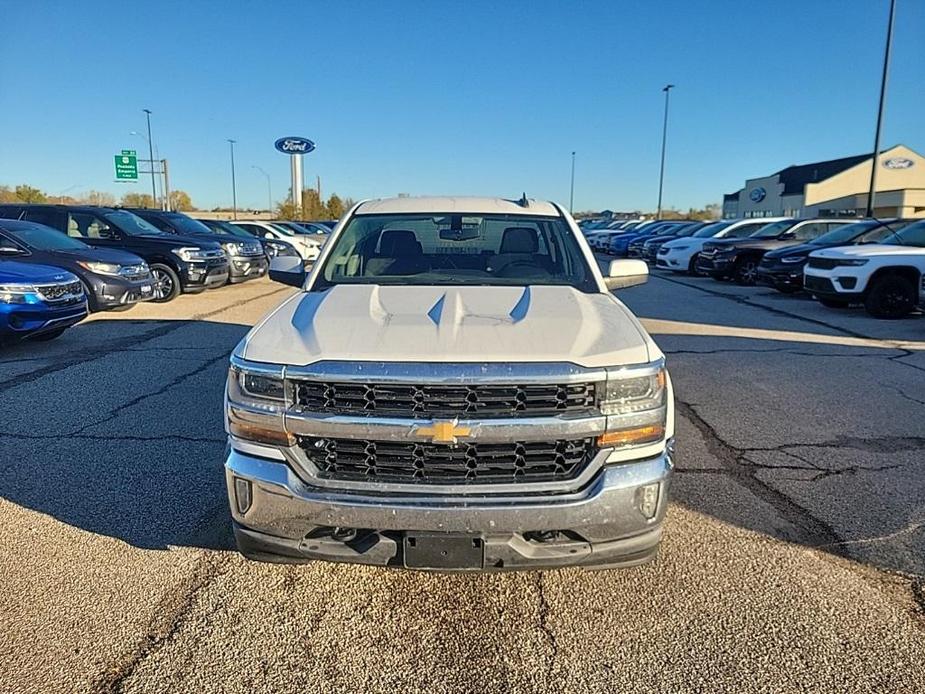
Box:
[0,0,925,209]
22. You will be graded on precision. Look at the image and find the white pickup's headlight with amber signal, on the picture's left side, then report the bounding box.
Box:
[225,357,295,446]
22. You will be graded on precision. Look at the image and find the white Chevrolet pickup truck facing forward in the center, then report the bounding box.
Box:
[225,197,674,571]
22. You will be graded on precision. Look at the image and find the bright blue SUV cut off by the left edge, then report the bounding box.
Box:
[0,260,87,343]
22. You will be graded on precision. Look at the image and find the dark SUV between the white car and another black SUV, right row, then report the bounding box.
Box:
[697,219,852,285]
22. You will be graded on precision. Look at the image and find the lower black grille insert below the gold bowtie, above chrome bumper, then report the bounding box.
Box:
[299,437,596,484]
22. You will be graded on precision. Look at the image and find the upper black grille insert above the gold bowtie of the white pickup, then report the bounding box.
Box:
[295,381,594,419]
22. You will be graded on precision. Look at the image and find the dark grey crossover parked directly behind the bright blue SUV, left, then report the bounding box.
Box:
[0,219,154,311]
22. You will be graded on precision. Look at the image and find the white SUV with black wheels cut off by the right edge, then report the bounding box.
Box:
[803,220,925,318]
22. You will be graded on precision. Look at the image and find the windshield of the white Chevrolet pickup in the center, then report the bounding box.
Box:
[315,213,597,292]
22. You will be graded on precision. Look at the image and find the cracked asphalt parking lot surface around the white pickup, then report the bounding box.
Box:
[0,274,925,692]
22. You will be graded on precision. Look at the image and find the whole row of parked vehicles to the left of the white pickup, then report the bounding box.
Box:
[0,204,336,342]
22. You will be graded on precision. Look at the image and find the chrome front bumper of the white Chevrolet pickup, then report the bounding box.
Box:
[225,448,672,571]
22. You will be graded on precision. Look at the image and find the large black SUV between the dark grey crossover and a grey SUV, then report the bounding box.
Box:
[0,205,228,302]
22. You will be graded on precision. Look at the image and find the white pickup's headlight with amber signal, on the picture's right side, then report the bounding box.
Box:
[597,360,668,447]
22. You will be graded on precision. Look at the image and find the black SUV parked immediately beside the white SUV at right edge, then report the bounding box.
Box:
[758,219,915,294]
